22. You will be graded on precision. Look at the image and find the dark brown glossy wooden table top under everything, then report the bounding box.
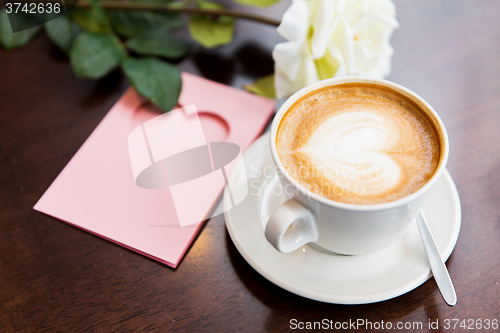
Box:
[0,0,500,332]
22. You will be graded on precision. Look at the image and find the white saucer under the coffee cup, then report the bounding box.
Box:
[223,134,461,304]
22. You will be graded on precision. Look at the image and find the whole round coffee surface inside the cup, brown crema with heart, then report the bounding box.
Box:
[276,83,440,205]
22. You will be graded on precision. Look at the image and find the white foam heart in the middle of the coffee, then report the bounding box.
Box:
[299,111,401,195]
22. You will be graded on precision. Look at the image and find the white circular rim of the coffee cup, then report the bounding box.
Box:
[269,76,449,211]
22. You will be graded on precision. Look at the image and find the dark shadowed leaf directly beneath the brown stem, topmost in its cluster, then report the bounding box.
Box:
[110,10,183,37]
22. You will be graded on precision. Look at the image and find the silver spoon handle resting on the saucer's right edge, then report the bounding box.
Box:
[416,212,457,306]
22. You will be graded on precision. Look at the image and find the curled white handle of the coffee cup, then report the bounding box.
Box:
[265,199,319,253]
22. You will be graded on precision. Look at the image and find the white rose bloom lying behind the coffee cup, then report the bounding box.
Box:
[273,0,399,98]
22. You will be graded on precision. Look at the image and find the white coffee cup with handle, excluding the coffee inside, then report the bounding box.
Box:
[265,77,449,255]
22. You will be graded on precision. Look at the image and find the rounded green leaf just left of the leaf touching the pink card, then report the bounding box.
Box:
[69,31,125,78]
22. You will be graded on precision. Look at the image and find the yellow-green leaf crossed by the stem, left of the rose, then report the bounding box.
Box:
[189,1,234,48]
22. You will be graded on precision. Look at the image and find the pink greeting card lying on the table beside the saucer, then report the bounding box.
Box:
[34,73,274,267]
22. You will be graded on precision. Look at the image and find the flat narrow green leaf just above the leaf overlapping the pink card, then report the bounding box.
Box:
[125,32,191,59]
